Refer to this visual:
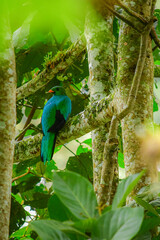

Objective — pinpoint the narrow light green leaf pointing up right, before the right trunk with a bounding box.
[112,170,145,209]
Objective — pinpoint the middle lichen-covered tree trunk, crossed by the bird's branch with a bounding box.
[85,9,114,202]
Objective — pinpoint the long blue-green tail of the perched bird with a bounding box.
[41,132,56,164]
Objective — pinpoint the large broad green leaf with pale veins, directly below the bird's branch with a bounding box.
[53,171,98,219]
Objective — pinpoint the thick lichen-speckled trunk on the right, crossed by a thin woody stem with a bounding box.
[117,0,156,199]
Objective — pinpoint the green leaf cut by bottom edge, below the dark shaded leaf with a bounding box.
[30,220,85,240]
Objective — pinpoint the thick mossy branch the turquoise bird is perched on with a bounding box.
[14,97,112,162]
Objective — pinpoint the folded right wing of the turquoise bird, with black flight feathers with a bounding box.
[48,96,71,132]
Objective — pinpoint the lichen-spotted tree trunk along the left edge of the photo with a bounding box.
[0,0,16,240]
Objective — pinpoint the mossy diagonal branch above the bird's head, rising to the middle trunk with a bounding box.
[16,35,85,100]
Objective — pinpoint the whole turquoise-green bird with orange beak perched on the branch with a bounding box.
[41,86,72,164]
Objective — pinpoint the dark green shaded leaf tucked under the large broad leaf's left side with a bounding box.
[48,194,75,222]
